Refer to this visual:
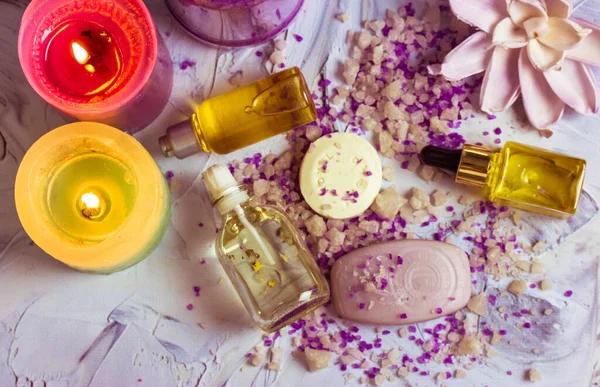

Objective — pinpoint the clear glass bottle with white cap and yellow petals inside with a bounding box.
[204,165,329,332]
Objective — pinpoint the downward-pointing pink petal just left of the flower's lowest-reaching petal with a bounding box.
[479,46,520,114]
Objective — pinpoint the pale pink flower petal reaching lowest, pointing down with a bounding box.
[519,48,565,129]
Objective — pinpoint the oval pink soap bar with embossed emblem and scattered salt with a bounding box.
[331,240,471,324]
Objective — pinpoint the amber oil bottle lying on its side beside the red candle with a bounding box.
[159,67,317,159]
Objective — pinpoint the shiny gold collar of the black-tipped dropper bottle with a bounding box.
[456,144,494,187]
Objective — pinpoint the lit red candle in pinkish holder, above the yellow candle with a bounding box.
[19,0,173,132]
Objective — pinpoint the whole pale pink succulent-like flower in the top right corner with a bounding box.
[429,0,600,129]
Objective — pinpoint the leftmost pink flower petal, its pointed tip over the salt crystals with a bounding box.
[429,31,492,80]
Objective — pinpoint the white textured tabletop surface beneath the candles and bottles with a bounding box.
[0,0,600,387]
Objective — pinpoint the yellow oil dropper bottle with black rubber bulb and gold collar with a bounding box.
[419,141,586,218]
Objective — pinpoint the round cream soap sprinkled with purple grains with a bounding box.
[300,133,381,219]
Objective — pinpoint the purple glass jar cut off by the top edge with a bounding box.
[165,0,304,47]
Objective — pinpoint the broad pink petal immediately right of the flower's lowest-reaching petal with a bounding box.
[544,59,598,115]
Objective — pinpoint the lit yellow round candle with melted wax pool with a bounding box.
[15,122,170,273]
